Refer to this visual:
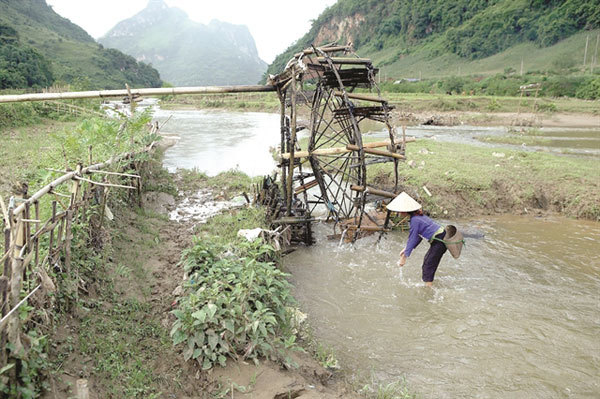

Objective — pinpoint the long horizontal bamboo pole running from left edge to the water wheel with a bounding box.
[0,85,277,103]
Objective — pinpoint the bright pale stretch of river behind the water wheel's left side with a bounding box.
[154,109,280,176]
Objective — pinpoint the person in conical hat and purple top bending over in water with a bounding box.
[387,192,447,287]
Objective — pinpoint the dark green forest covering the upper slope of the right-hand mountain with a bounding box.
[268,0,600,80]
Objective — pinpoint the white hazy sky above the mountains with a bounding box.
[46,0,336,63]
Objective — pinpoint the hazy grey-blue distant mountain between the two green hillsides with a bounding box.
[99,0,267,86]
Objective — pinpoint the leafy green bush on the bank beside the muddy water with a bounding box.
[171,237,295,370]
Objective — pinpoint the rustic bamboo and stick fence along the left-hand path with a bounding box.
[0,133,158,381]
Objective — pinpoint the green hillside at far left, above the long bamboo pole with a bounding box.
[0,0,162,90]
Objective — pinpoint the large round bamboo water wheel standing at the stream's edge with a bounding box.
[270,44,405,244]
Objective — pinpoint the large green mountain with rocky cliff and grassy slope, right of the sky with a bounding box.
[268,0,600,77]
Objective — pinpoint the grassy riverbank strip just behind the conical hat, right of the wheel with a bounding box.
[368,139,600,220]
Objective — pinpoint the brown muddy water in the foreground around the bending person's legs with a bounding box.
[285,217,600,398]
